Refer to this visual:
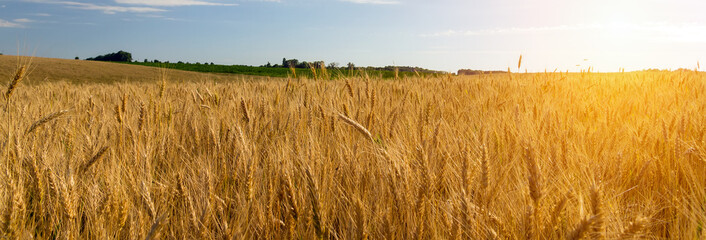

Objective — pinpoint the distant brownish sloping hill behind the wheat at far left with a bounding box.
[0,55,267,84]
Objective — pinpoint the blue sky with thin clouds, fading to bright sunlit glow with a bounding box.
[0,0,706,72]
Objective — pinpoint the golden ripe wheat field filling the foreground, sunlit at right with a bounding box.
[0,57,706,239]
